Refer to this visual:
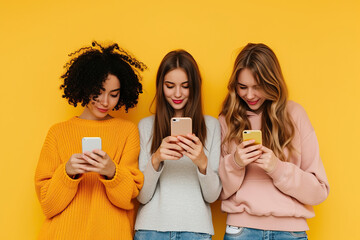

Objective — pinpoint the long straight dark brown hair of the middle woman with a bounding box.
[151,49,206,153]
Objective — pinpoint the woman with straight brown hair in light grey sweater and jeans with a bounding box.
[135,50,221,240]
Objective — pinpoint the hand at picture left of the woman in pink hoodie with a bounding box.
[234,140,262,167]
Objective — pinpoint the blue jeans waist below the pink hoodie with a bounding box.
[224,227,307,240]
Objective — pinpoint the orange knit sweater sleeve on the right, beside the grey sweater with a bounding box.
[100,126,144,210]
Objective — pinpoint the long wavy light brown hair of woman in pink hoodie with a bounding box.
[221,43,295,161]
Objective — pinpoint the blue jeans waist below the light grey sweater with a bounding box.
[134,230,211,240]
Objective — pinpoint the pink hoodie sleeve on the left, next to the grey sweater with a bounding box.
[219,115,245,200]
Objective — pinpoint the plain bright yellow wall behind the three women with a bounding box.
[0,0,360,240]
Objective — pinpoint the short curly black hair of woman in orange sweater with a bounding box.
[60,41,147,112]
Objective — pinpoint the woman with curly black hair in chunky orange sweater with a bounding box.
[35,42,146,240]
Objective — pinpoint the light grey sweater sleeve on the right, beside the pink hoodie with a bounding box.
[197,118,221,203]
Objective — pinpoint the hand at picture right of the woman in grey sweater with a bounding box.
[177,134,208,174]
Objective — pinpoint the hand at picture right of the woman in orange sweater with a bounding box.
[84,149,116,179]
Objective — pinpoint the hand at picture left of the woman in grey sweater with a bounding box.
[151,136,184,171]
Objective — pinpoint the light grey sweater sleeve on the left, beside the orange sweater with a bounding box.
[137,118,163,204]
